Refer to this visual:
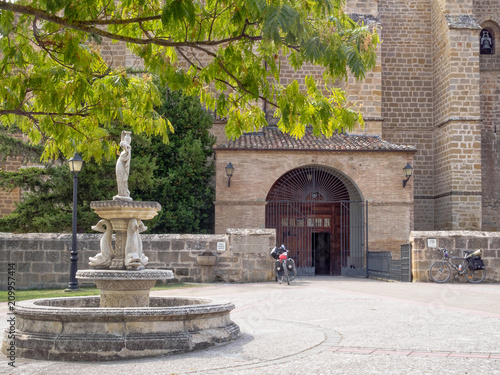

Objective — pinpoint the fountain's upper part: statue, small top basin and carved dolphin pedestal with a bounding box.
[89,131,161,271]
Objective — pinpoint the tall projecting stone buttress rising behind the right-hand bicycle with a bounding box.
[432,1,482,230]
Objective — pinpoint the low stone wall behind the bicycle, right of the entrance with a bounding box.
[410,231,500,282]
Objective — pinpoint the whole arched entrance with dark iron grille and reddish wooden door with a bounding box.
[266,166,366,276]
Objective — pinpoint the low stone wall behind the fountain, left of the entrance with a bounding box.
[0,229,276,290]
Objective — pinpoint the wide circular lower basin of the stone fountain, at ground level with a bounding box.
[3,297,240,361]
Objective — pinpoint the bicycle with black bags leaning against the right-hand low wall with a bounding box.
[429,249,486,284]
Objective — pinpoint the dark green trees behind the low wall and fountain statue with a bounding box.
[0,90,215,233]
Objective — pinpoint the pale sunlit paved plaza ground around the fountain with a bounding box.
[0,277,500,375]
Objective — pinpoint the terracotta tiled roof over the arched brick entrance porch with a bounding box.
[215,127,416,151]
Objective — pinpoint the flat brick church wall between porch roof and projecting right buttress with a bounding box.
[378,0,434,229]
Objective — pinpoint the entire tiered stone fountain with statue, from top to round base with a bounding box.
[2,131,240,361]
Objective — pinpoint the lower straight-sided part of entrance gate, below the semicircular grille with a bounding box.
[266,201,367,277]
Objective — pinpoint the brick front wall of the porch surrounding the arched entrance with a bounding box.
[215,150,413,253]
